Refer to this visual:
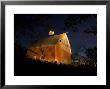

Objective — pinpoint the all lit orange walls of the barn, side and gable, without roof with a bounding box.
[26,33,72,64]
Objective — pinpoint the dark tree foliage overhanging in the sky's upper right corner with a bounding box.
[64,14,97,35]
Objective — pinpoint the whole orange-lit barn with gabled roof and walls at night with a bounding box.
[26,33,72,64]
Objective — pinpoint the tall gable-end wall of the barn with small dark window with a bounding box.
[55,33,71,64]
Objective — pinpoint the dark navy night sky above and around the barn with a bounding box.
[14,14,97,55]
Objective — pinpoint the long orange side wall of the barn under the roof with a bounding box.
[26,45,55,62]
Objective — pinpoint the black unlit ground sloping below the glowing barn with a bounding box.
[14,50,97,76]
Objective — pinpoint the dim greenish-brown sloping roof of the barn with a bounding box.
[32,35,59,47]
